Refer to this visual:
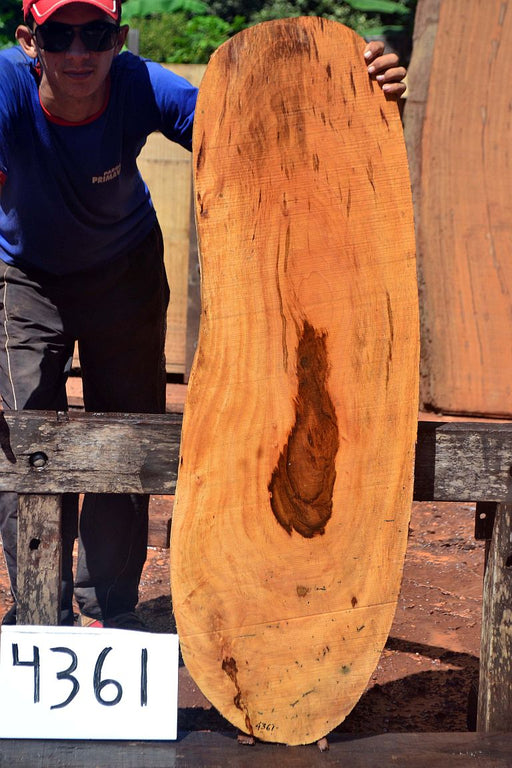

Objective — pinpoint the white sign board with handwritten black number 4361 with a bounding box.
[0,626,178,740]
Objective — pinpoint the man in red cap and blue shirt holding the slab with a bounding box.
[0,0,405,629]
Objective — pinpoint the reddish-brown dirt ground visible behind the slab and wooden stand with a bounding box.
[0,378,484,734]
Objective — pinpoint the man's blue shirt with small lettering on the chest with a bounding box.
[0,47,197,274]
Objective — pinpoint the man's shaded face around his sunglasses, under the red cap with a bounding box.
[33,3,126,111]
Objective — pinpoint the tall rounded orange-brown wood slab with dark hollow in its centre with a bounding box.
[171,18,418,744]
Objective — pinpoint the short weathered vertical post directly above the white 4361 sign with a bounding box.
[16,494,62,626]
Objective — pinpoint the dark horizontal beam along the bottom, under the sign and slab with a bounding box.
[0,731,512,768]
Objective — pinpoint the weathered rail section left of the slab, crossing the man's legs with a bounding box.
[0,411,182,494]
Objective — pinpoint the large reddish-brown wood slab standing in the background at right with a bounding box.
[405,0,512,416]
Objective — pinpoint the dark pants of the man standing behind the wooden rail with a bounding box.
[0,226,169,624]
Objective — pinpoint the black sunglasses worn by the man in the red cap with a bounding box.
[33,21,120,53]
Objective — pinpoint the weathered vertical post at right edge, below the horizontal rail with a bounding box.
[477,504,512,732]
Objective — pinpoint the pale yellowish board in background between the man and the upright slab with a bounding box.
[137,64,205,374]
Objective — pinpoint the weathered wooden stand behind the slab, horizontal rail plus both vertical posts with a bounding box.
[0,411,512,732]
